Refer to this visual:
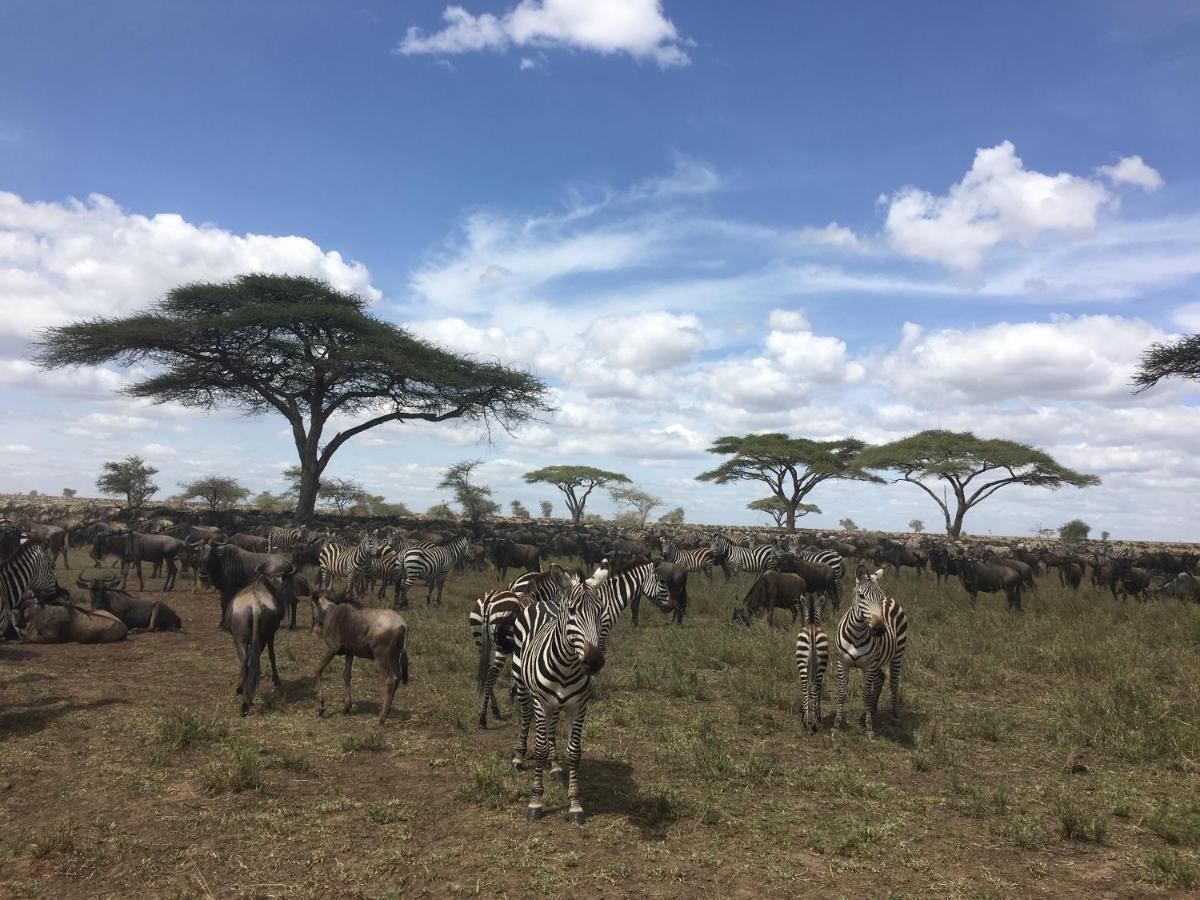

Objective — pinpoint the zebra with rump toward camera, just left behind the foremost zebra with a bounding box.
[467,565,580,728]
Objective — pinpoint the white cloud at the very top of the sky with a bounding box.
[396,0,691,68]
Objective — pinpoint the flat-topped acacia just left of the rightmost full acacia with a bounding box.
[696,432,880,532]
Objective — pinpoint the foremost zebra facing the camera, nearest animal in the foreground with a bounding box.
[521,586,606,824]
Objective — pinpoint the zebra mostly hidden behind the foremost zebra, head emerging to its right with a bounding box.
[511,563,673,775]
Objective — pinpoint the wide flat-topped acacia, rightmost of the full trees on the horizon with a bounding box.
[859,430,1100,538]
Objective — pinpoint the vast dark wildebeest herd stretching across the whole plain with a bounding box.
[0,498,1200,720]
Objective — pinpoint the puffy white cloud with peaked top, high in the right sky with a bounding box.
[886,140,1111,269]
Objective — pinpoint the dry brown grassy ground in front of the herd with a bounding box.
[0,561,1200,898]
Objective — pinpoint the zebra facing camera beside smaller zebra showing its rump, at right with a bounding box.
[833,566,908,739]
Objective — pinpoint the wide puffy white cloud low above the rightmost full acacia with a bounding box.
[876,316,1169,404]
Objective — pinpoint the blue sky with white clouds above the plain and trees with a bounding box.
[0,0,1200,539]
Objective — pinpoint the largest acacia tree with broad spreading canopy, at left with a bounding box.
[37,274,550,520]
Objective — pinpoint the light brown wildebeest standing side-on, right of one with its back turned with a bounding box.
[311,589,408,725]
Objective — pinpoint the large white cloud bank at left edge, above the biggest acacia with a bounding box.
[0,192,380,338]
